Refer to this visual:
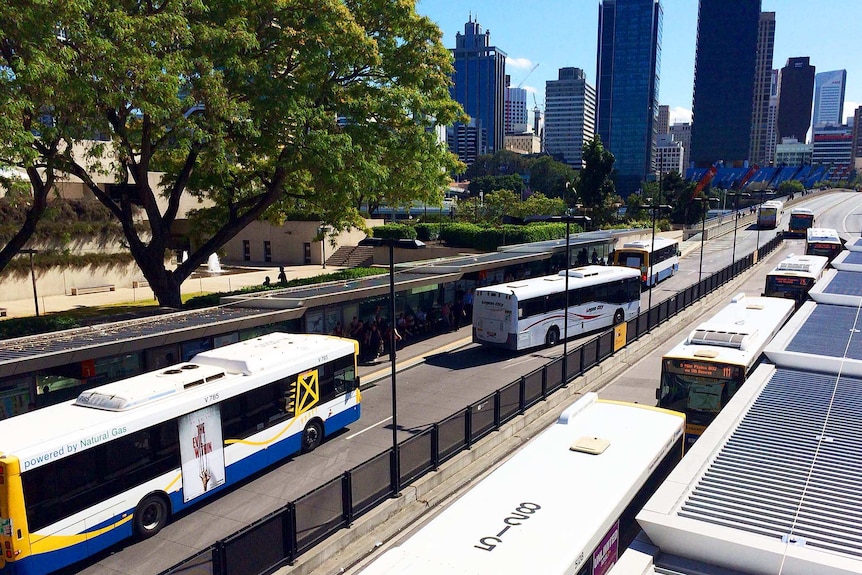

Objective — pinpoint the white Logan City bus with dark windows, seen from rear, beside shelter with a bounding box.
[473,265,641,350]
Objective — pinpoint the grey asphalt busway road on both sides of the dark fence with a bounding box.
[65,194,862,575]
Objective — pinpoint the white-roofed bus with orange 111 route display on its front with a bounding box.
[656,293,795,443]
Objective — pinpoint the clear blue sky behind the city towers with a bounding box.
[417,0,862,125]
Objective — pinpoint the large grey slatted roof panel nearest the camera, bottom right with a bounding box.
[677,369,862,559]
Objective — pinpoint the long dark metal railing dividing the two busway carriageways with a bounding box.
[160,236,783,575]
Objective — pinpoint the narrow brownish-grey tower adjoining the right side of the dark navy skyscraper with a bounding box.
[749,12,775,166]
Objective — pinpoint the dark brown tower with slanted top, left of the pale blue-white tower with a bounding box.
[778,56,814,142]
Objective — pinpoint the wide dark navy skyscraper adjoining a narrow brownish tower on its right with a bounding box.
[690,0,760,167]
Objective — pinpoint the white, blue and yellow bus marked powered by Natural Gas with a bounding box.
[0,333,360,575]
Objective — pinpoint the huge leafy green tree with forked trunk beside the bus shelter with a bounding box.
[0,0,463,307]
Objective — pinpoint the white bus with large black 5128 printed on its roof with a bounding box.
[360,393,685,575]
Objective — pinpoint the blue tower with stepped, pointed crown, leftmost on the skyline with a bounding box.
[449,17,506,162]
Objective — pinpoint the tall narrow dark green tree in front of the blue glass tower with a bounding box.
[576,134,617,226]
